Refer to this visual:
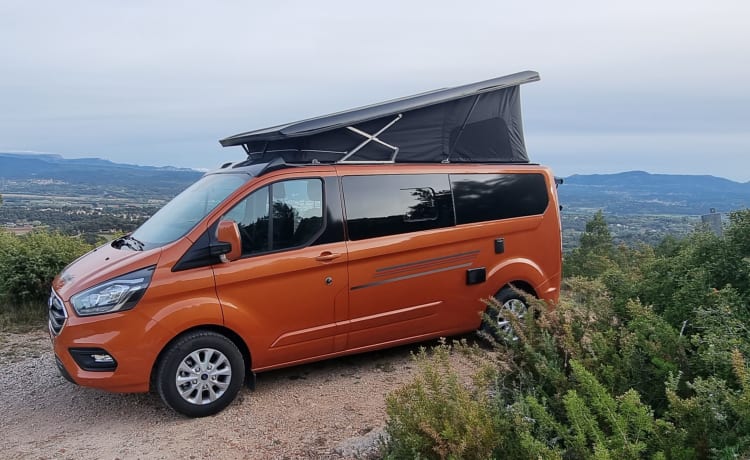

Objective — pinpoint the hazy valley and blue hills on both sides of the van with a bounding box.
[0,153,750,248]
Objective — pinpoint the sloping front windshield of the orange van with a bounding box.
[132,174,251,248]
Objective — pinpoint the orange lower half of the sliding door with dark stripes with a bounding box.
[349,230,478,348]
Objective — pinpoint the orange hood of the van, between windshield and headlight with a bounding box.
[52,243,162,302]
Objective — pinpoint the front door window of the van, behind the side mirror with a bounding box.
[223,179,323,255]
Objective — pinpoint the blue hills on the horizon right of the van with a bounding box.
[558,171,750,215]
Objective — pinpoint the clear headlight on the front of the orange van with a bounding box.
[70,267,155,316]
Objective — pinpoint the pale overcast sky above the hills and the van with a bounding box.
[0,0,750,182]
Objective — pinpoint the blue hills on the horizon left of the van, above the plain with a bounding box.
[0,152,203,198]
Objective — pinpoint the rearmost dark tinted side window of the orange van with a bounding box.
[450,174,549,224]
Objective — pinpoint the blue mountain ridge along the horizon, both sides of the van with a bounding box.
[0,152,750,215]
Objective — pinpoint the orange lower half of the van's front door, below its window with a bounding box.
[214,242,347,368]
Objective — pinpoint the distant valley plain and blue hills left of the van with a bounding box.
[0,153,203,243]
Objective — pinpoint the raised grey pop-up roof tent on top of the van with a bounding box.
[220,71,539,163]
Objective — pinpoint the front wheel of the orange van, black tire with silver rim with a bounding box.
[156,331,245,417]
